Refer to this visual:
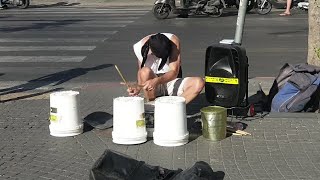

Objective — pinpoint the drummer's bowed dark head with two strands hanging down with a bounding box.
[141,33,172,70]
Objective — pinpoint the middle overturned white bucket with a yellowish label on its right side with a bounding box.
[112,97,147,144]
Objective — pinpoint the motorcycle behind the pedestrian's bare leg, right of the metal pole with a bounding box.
[256,0,309,15]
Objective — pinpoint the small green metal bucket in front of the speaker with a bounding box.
[200,106,227,141]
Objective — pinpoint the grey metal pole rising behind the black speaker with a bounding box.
[234,0,248,45]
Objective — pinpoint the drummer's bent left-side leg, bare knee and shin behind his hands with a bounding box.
[138,67,157,101]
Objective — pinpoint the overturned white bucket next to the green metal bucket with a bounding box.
[153,96,189,146]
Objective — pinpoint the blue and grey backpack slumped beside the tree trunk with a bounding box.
[269,64,320,112]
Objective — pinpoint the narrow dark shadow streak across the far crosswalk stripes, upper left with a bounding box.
[0,19,84,32]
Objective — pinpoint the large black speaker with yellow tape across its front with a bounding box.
[205,44,248,108]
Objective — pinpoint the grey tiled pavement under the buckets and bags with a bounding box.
[0,80,320,180]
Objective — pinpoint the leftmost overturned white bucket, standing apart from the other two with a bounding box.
[49,91,83,137]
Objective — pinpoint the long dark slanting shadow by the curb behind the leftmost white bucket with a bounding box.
[0,64,113,95]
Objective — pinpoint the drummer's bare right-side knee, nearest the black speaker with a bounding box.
[180,77,204,103]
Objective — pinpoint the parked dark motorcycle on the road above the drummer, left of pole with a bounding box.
[152,0,226,19]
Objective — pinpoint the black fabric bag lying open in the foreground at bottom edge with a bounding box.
[89,150,215,180]
